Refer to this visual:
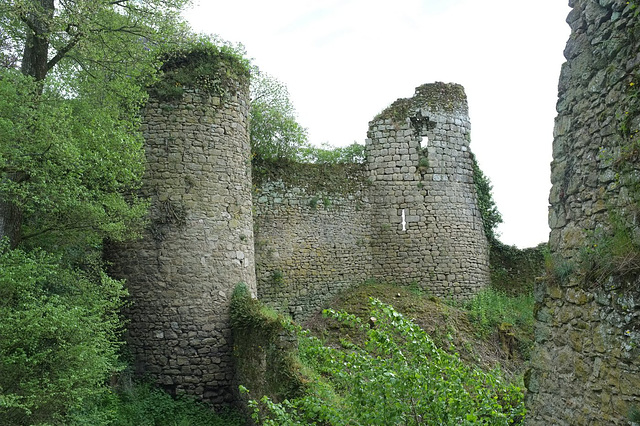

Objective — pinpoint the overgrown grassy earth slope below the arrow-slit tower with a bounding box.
[303,283,533,379]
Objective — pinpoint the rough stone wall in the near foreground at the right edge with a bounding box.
[526,0,640,425]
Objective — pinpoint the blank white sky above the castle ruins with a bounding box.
[185,0,570,247]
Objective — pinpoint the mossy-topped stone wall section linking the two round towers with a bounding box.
[254,164,371,320]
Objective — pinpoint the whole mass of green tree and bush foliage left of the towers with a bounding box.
[0,0,205,425]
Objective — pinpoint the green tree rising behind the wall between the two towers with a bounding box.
[249,71,308,160]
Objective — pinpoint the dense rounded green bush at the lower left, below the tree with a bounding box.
[0,243,124,425]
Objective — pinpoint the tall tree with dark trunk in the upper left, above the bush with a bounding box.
[0,0,188,247]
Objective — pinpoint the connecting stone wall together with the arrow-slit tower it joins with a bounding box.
[254,83,489,319]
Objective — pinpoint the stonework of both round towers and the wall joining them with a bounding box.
[108,83,489,405]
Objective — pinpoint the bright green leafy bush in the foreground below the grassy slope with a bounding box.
[253,299,524,425]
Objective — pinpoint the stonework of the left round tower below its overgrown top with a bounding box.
[109,85,255,405]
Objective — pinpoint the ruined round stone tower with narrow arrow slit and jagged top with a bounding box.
[366,83,489,299]
